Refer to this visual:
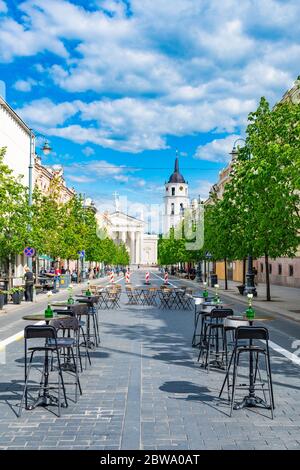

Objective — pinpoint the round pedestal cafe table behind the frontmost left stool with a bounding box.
[22,313,70,410]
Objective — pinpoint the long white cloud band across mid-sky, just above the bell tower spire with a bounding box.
[18,98,255,153]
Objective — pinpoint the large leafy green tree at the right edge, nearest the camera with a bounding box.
[218,98,300,300]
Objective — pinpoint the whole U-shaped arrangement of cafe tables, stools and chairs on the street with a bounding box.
[19,284,274,418]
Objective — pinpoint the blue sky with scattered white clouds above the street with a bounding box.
[0,0,300,221]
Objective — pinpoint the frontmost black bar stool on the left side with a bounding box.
[18,325,68,417]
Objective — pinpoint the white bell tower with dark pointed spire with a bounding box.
[163,156,190,234]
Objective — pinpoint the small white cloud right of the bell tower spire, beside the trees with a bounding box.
[194,134,240,163]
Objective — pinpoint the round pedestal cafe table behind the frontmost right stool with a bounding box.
[222,316,267,410]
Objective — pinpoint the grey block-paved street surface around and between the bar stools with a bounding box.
[0,273,300,450]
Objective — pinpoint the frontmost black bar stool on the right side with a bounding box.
[219,326,275,419]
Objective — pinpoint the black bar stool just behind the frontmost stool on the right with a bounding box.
[198,308,233,372]
